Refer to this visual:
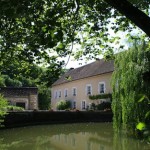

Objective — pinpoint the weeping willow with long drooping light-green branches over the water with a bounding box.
[112,43,150,131]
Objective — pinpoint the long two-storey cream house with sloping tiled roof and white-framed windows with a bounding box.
[51,59,114,110]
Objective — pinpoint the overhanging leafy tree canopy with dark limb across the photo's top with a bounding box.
[0,0,150,64]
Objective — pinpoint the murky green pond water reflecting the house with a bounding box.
[0,123,150,150]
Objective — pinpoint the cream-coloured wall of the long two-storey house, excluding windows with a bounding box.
[51,73,112,110]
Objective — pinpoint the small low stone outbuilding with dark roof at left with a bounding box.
[0,87,38,110]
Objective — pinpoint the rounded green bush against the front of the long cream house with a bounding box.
[57,100,71,110]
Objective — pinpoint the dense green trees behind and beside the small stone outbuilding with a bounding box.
[0,61,63,109]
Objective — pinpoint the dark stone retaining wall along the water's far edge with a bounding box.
[3,111,113,128]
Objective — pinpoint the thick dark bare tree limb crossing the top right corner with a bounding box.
[105,0,150,37]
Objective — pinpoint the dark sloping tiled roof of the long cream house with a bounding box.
[53,59,114,86]
